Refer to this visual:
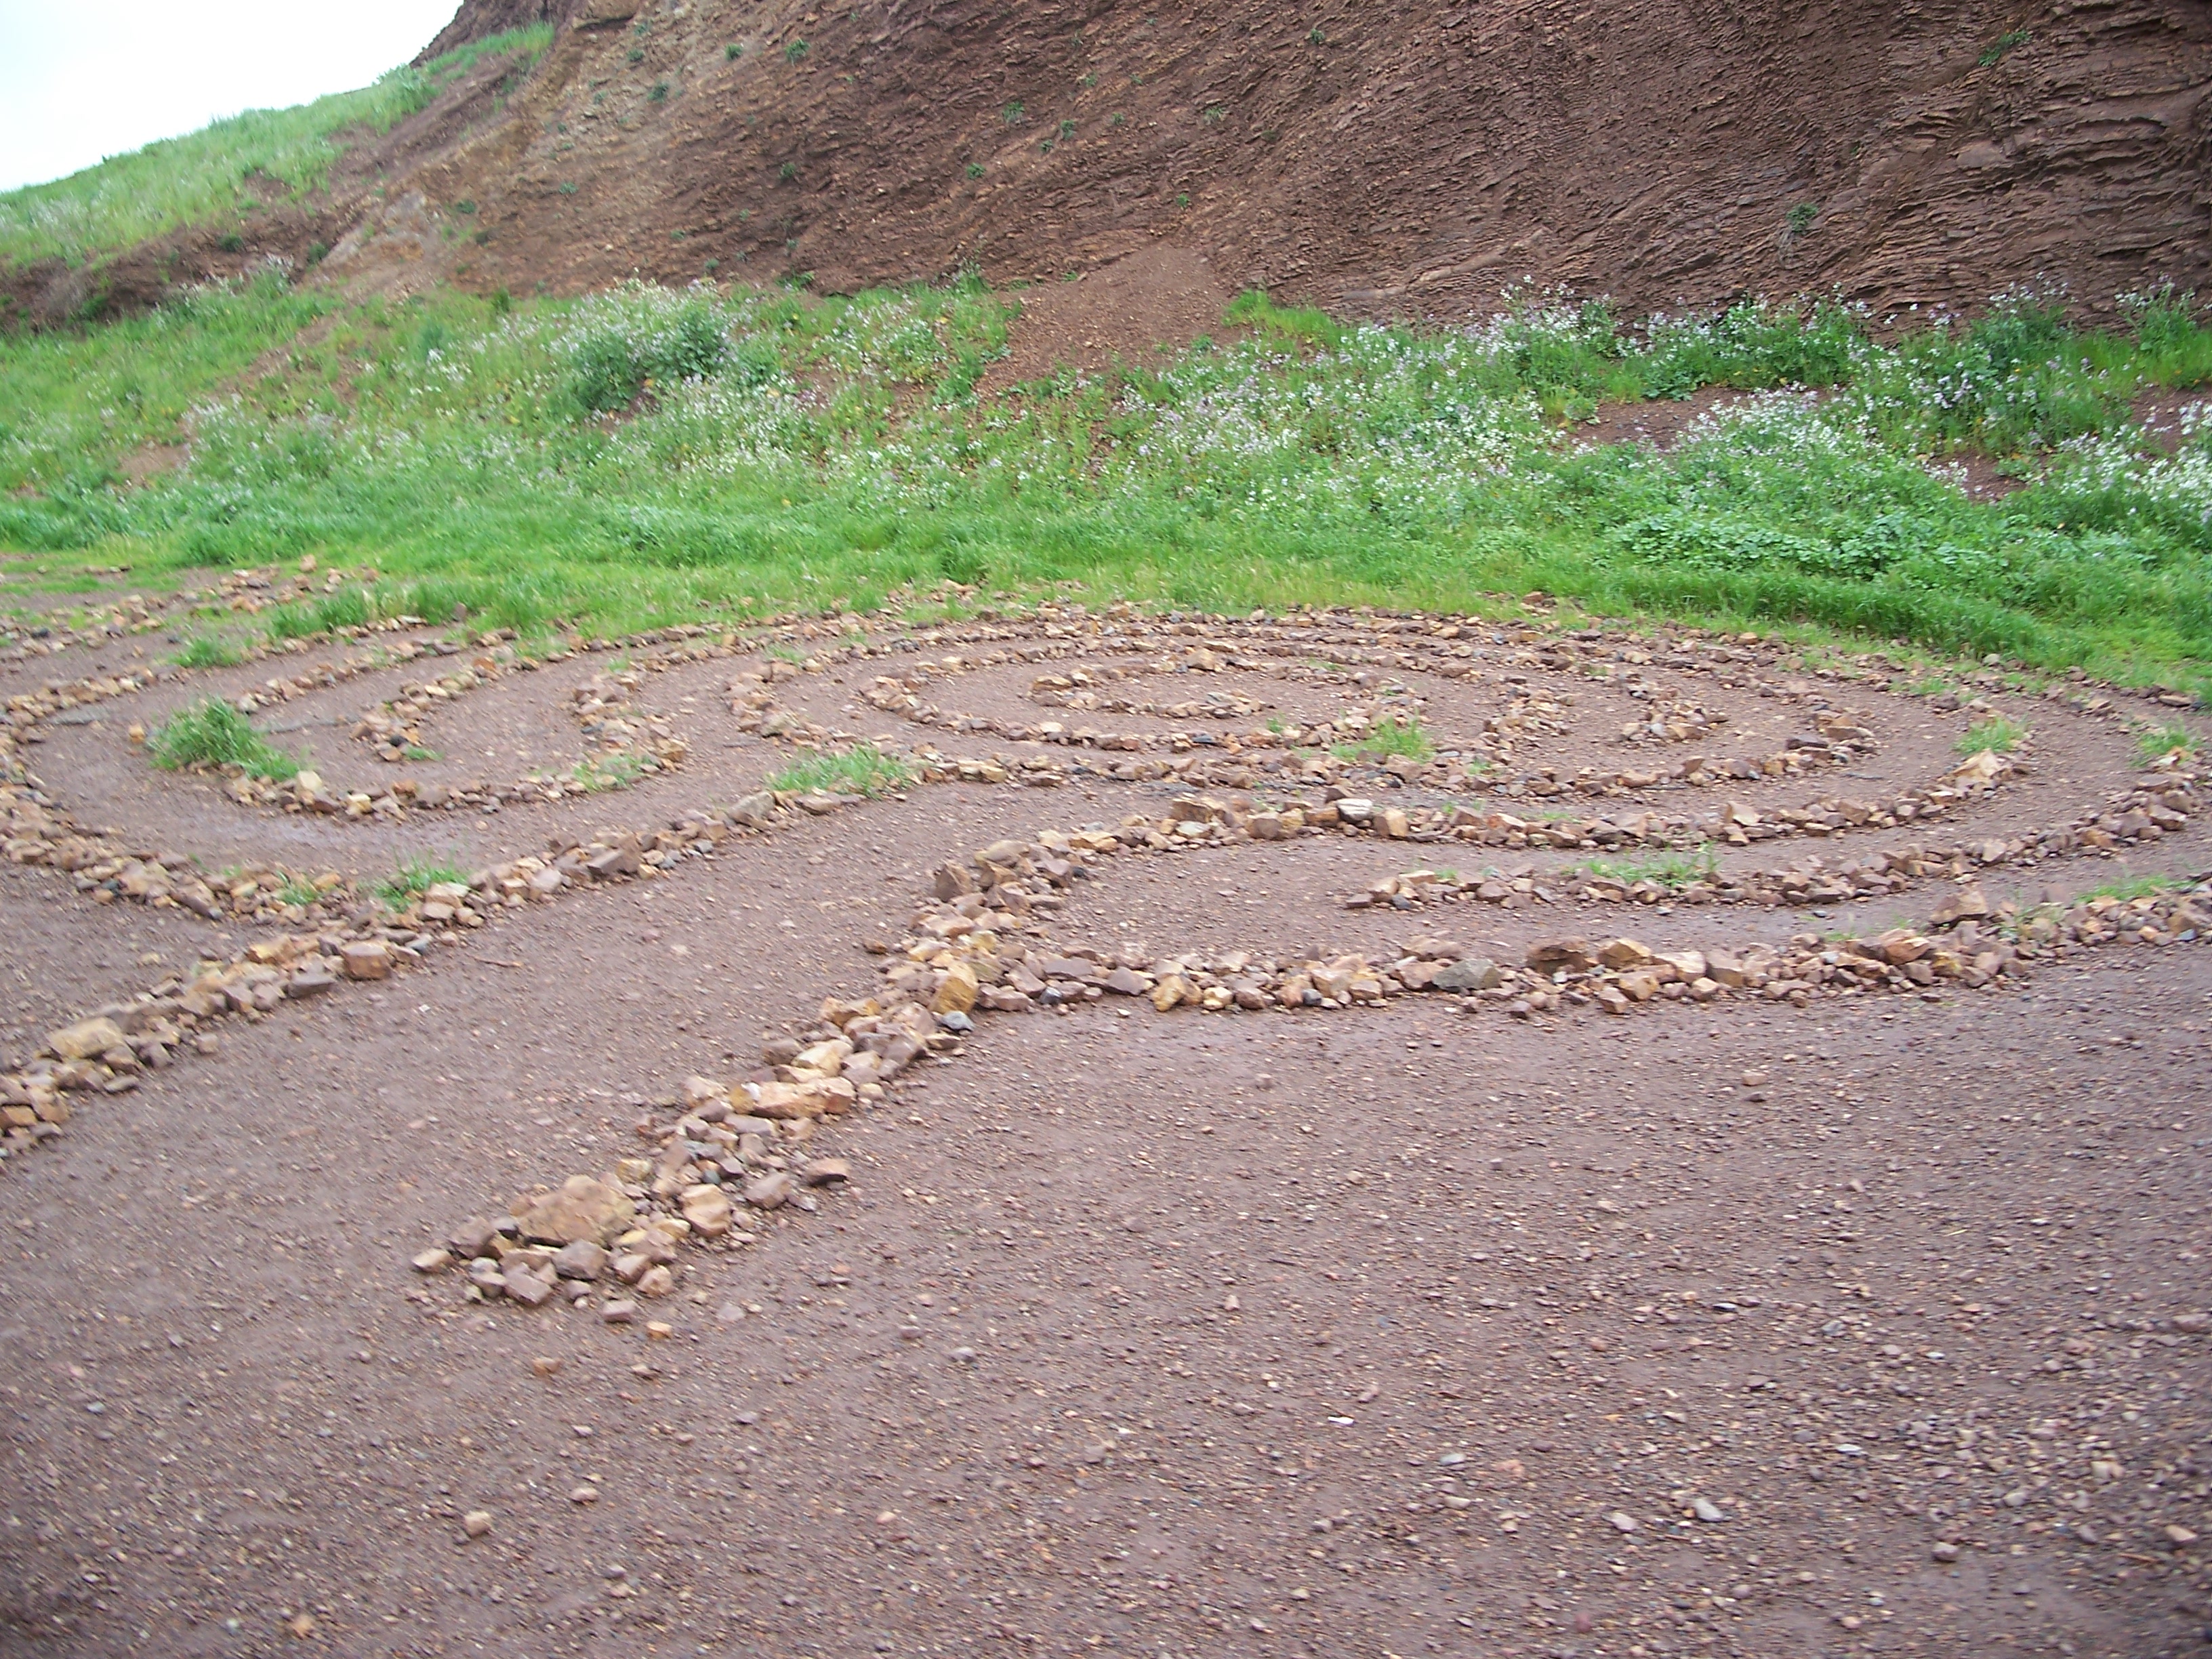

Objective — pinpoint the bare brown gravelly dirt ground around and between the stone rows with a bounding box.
[0,588,2212,1659]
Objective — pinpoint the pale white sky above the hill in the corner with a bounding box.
[0,0,460,190]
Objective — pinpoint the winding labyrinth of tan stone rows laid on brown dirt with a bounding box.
[0,571,2212,1652]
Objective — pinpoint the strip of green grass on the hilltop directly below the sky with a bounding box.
[0,24,553,268]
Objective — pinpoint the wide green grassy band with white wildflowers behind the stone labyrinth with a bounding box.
[0,267,2212,684]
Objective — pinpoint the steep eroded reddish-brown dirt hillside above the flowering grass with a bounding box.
[392,0,2212,314]
